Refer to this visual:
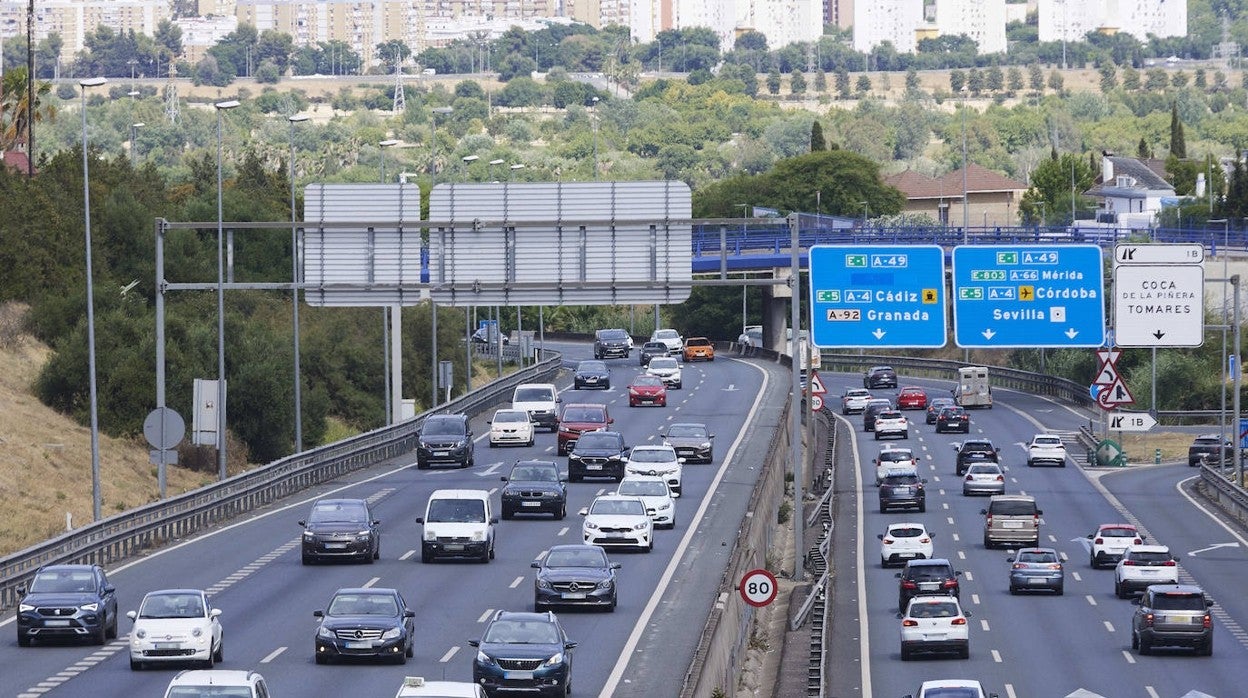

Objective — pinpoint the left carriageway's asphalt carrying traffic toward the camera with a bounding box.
[0,345,787,698]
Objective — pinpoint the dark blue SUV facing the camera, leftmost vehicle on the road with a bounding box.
[17,564,117,647]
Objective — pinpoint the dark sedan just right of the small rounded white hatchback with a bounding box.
[312,587,416,664]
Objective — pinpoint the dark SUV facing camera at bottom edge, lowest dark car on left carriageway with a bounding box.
[468,611,577,698]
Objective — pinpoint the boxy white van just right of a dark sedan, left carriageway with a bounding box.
[416,489,498,562]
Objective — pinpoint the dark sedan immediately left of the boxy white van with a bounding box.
[300,499,382,564]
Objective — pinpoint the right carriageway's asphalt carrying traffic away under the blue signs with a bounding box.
[824,375,1248,698]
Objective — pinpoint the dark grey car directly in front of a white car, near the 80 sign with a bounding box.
[532,546,620,612]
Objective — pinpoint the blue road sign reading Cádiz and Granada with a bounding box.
[810,245,948,348]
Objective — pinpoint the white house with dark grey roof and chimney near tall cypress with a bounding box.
[1083,154,1174,226]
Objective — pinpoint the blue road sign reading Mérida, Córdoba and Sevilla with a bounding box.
[952,245,1104,348]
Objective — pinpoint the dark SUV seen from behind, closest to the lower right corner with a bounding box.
[1131,584,1213,657]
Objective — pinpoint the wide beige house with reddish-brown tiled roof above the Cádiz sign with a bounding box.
[884,162,1027,227]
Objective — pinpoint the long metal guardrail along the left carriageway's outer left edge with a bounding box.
[0,351,562,611]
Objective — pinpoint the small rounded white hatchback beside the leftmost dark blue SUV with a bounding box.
[126,589,223,671]
